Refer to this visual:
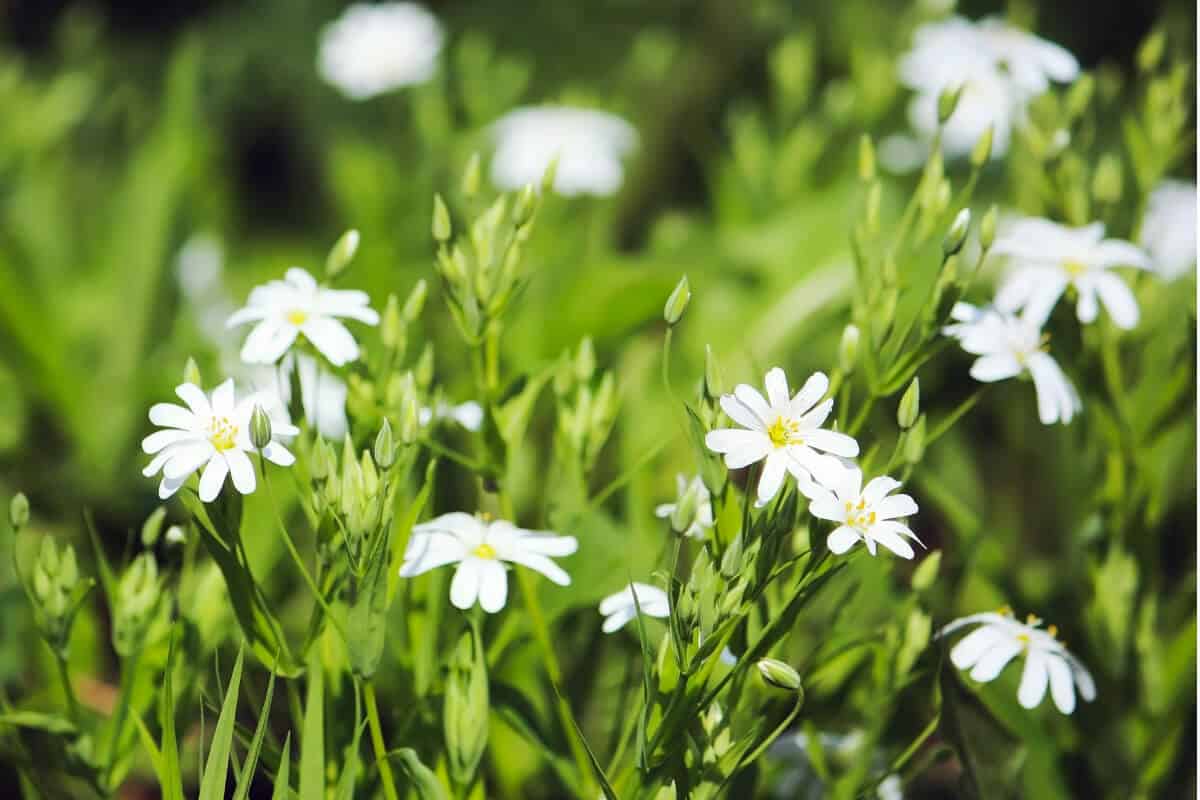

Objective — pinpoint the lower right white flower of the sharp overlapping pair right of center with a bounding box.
[809,468,920,559]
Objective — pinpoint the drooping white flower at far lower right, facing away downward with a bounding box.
[938,609,1096,714]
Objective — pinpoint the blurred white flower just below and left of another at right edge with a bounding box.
[942,302,1082,425]
